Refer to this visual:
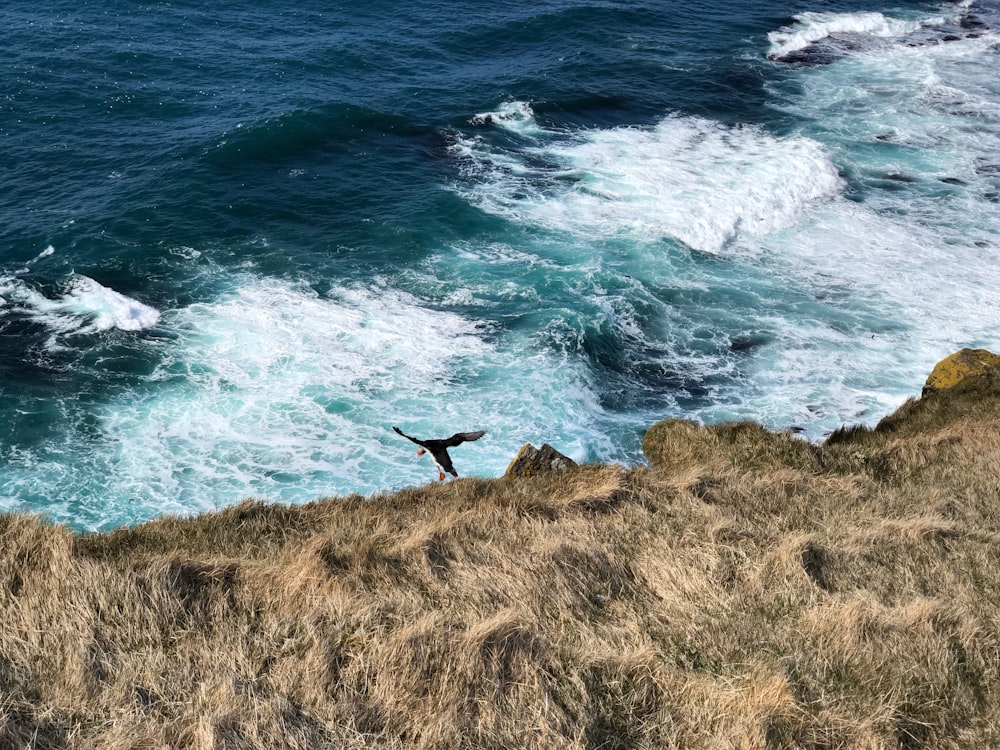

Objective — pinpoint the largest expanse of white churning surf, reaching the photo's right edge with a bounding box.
[444,4,1000,452]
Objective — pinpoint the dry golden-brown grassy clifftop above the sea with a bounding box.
[0,354,1000,750]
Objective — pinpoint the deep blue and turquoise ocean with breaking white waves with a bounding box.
[0,0,1000,531]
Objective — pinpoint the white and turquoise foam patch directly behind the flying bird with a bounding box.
[9,276,610,528]
